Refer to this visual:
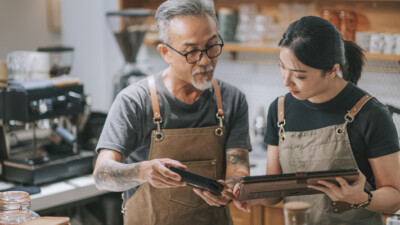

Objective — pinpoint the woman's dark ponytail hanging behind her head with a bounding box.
[342,41,365,84]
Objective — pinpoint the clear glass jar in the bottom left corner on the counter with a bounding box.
[0,191,40,224]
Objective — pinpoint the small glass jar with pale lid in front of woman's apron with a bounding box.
[283,201,310,225]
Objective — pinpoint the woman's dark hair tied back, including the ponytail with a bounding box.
[279,16,365,84]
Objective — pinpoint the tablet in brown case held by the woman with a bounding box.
[238,169,358,200]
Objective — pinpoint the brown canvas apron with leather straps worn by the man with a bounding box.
[123,76,232,225]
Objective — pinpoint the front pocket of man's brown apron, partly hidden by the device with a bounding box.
[168,160,217,208]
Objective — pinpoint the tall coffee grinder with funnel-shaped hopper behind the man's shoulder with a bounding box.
[106,9,153,98]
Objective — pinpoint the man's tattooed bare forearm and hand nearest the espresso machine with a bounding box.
[93,149,186,192]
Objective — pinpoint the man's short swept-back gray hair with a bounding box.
[156,0,218,43]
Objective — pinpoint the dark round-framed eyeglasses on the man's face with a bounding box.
[164,34,224,64]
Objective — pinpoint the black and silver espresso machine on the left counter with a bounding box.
[0,78,94,185]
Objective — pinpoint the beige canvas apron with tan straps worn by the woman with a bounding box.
[278,95,383,225]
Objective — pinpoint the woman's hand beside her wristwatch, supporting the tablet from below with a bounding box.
[307,171,368,204]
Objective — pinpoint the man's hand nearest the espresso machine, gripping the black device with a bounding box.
[140,158,186,188]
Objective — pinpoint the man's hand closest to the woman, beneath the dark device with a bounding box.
[193,180,233,207]
